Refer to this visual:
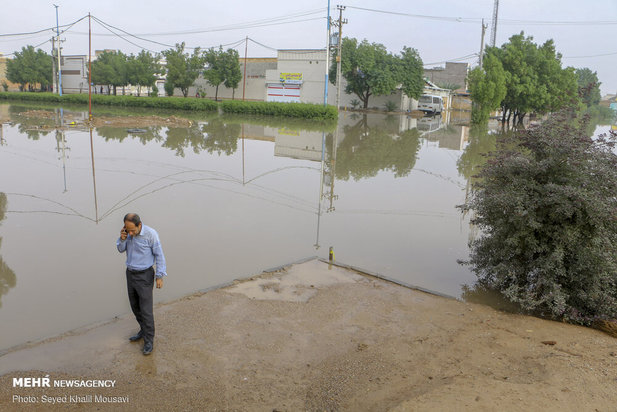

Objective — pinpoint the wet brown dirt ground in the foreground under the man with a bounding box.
[0,260,617,411]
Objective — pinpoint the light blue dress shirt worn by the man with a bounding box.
[116,223,167,278]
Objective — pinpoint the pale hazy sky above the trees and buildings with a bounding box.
[0,0,617,95]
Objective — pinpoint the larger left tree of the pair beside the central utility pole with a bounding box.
[329,37,402,109]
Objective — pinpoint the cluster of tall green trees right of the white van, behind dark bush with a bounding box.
[469,32,600,123]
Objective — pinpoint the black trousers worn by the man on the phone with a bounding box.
[126,268,154,342]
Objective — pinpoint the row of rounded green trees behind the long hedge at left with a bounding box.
[7,43,242,99]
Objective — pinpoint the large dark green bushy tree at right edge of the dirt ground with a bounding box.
[461,113,617,325]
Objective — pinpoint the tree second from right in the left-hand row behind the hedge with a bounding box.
[163,42,204,97]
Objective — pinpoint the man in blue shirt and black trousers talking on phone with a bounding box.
[116,213,167,355]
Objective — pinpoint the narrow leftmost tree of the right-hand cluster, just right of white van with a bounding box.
[469,54,506,124]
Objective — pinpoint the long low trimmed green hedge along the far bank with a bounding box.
[0,92,338,120]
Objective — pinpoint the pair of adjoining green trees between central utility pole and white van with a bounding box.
[329,37,424,109]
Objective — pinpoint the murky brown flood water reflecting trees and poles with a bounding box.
[0,105,600,350]
